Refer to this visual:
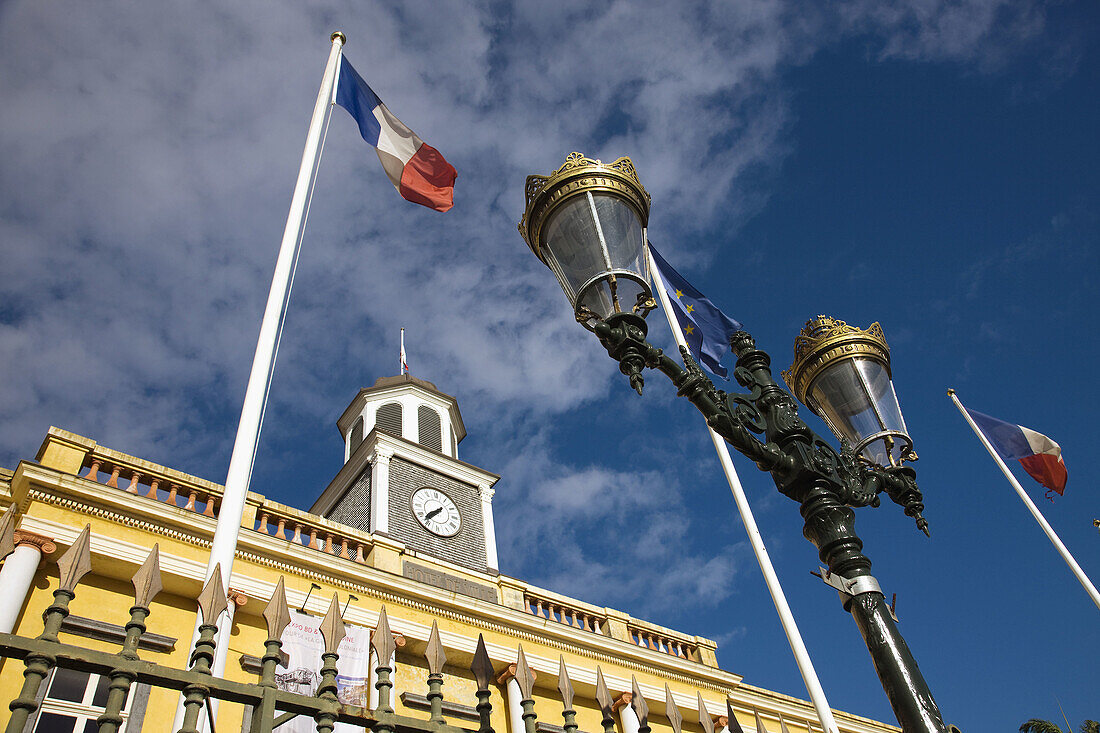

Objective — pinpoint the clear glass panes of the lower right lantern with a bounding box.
[806,357,912,466]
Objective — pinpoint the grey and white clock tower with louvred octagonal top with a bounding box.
[309,374,499,573]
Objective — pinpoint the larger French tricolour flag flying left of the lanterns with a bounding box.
[337,56,458,211]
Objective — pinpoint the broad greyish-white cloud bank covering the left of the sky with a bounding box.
[0,0,1069,611]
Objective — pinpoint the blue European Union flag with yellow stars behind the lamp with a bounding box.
[649,244,741,379]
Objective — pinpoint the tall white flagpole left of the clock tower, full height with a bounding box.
[172,32,345,730]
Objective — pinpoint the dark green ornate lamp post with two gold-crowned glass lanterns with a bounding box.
[519,153,947,733]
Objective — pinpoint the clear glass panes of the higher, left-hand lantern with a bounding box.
[541,190,650,321]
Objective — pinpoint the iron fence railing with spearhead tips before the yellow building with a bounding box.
[0,507,739,733]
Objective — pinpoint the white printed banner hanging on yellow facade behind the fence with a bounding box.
[275,611,371,733]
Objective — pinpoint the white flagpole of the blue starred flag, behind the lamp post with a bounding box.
[646,244,840,733]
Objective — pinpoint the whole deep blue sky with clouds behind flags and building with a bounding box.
[0,0,1100,731]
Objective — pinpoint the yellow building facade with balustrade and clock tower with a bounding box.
[0,376,899,733]
